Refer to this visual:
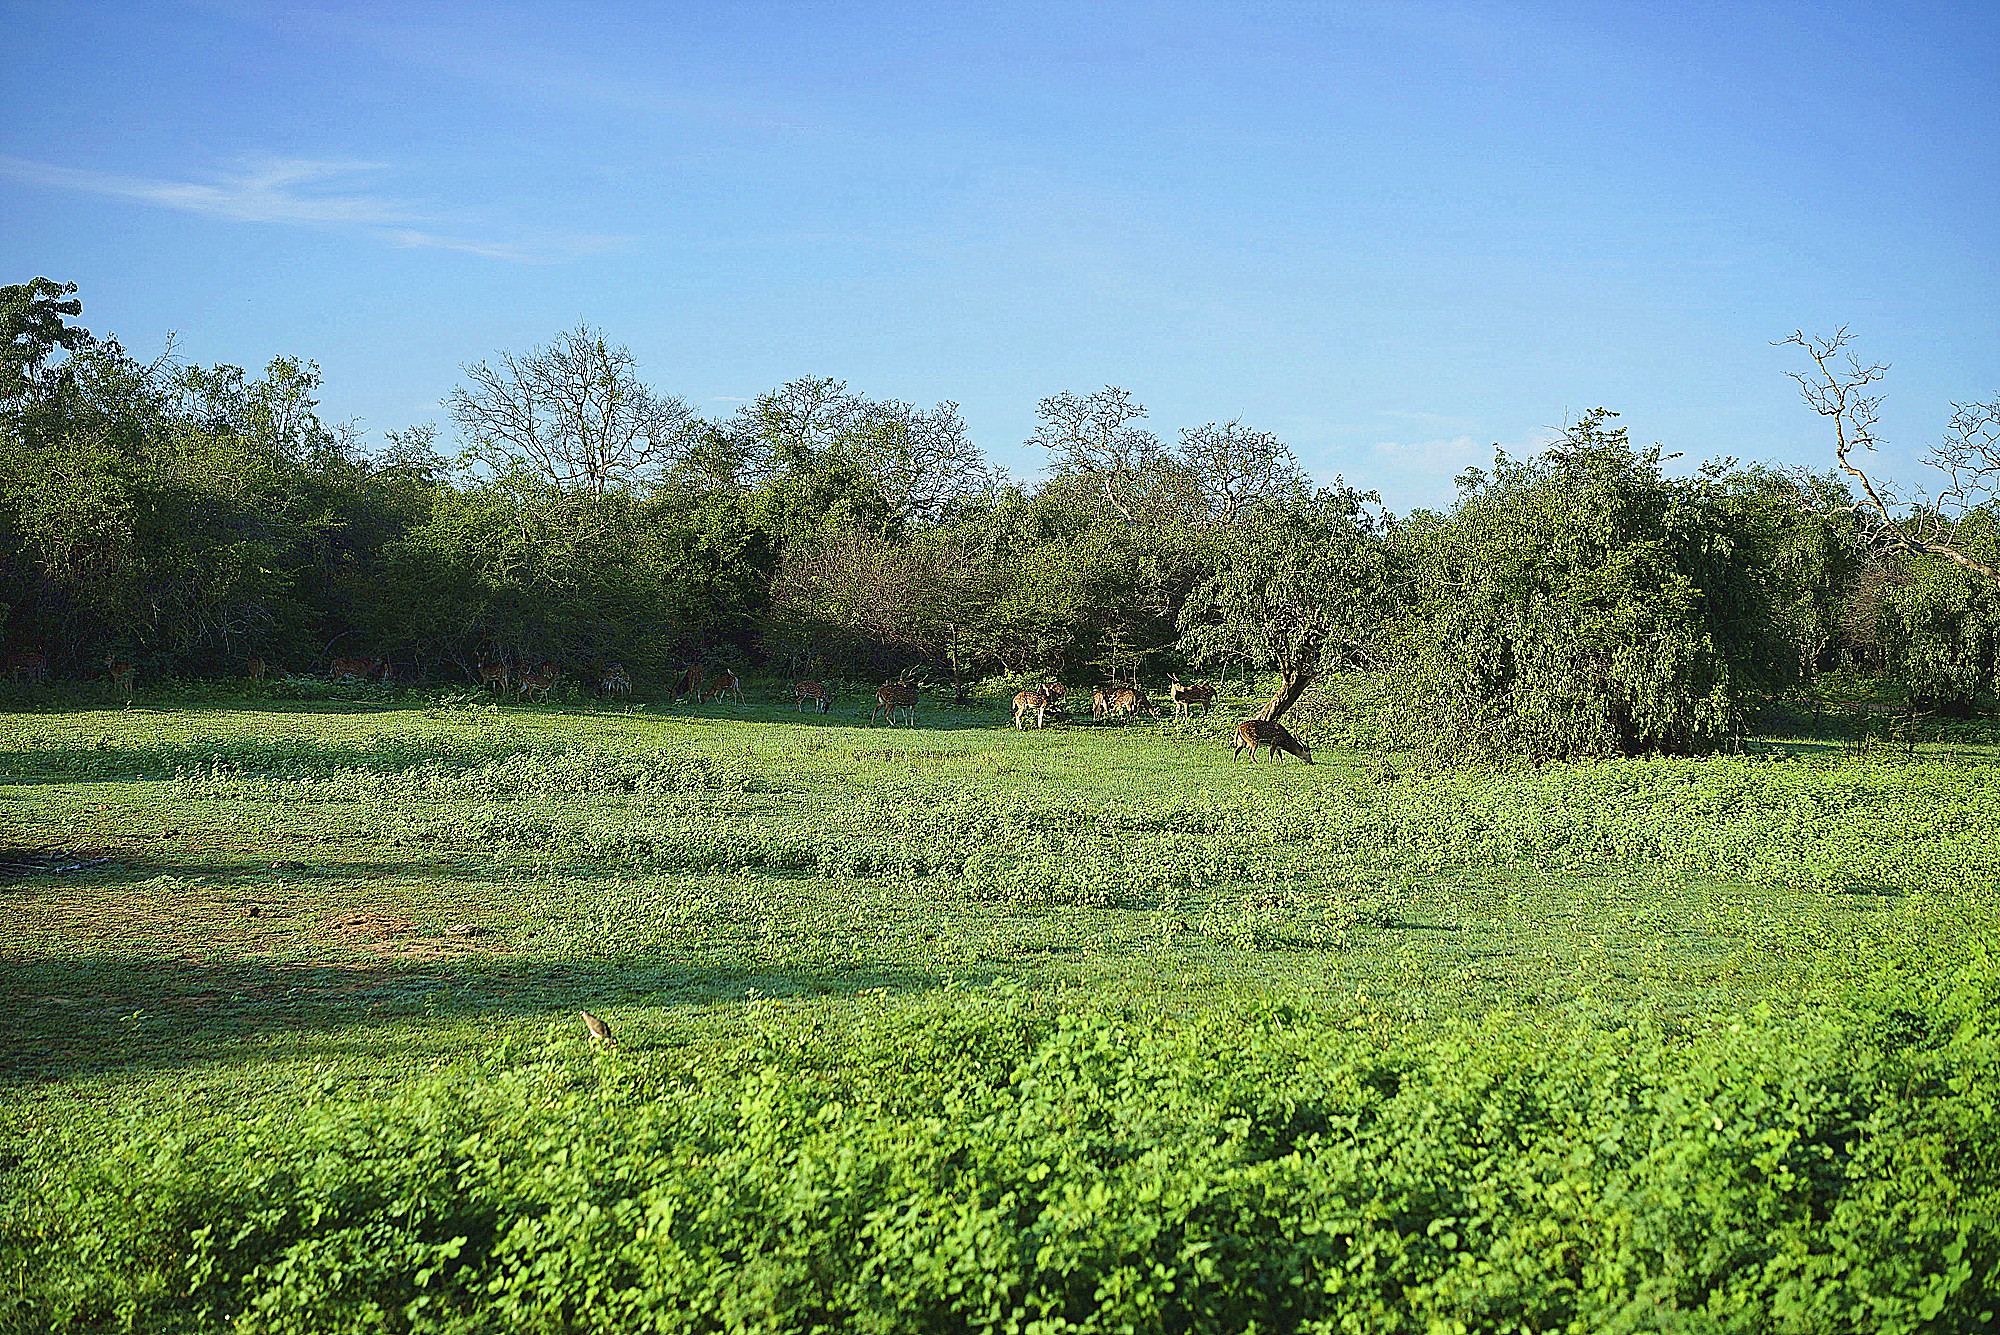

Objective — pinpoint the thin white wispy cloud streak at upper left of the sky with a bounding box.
[0,156,620,264]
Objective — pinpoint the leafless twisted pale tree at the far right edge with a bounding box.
[1778,326,2000,584]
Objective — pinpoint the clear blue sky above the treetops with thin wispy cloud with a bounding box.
[0,0,2000,510]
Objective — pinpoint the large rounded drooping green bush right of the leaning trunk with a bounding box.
[1386,410,1790,759]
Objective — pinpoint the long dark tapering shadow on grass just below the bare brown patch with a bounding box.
[0,951,968,1085]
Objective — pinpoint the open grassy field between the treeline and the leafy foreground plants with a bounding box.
[0,689,2000,1329]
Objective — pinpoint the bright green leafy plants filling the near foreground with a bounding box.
[0,959,2000,1335]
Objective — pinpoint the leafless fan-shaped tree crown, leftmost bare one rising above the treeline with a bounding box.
[446,324,698,494]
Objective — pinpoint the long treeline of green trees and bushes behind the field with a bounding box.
[0,280,2000,757]
